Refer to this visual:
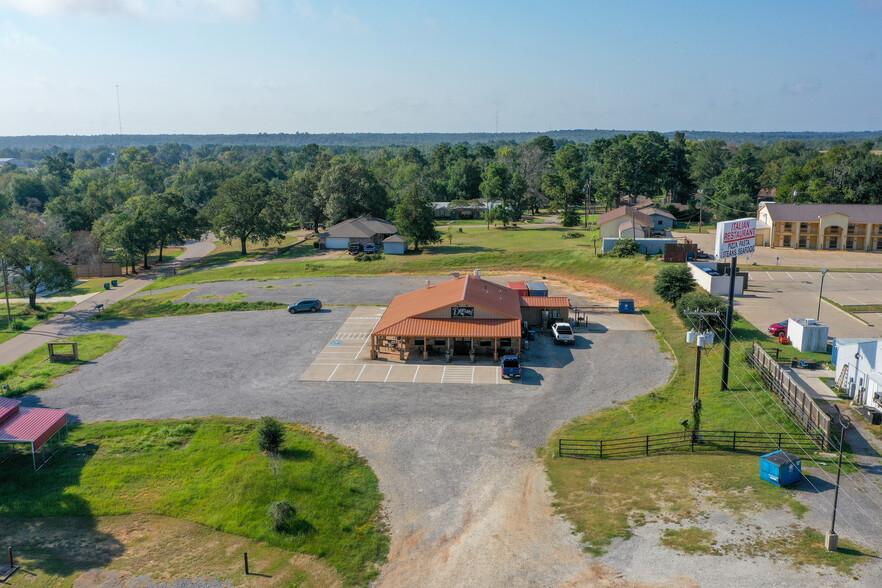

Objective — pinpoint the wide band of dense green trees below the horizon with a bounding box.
[0,132,882,308]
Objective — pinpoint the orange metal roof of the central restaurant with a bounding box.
[373,275,521,337]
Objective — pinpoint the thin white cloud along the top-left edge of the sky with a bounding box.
[0,0,261,20]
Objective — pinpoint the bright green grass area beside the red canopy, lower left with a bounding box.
[0,417,389,584]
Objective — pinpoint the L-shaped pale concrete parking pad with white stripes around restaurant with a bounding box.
[300,306,511,384]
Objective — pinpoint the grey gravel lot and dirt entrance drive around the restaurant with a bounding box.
[25,296,672,586]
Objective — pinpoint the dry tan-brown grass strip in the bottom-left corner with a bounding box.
[0,514,342,588]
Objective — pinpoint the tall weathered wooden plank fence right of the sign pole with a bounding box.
[748,343,831,449]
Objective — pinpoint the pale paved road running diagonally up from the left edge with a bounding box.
[0,239,214,365]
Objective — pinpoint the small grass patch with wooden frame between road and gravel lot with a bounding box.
[0,333,125,398]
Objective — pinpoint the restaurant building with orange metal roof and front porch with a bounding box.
[370,270,570,361]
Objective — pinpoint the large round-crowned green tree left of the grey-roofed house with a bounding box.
[203,172,287,255]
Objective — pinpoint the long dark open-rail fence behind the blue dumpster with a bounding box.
[557,431,824,459]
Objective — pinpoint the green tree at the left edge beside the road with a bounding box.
[0,235,76,309]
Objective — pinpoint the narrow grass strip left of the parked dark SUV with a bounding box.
[90,288,287,321]
